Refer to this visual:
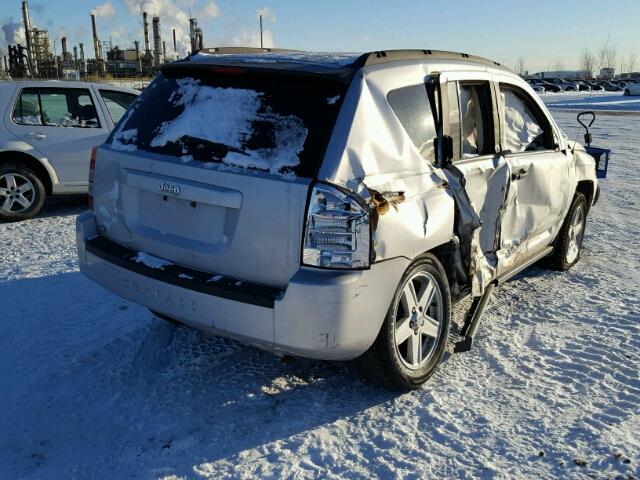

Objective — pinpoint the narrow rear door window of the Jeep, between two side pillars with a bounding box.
[459,83,494,158]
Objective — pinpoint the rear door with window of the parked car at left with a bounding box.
[6,87,108,186]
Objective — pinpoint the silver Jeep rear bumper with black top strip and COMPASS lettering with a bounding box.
[76,212,409,360]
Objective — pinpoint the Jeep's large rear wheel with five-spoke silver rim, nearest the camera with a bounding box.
[358,254,451,390]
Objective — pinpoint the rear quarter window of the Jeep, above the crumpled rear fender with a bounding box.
[387,84,437,162]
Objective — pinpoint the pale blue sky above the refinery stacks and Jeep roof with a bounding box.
[0,0,640,72]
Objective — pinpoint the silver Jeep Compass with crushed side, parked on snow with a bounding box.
[77,49,599,389]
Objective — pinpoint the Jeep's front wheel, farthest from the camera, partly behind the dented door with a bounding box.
[548,192,588,271]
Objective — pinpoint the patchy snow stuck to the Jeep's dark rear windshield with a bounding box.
[151,78,308,173]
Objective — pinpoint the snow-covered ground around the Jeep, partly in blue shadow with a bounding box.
[0,112,640,479]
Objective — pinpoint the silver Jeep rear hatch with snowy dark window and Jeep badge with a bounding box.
[93,64,347,287]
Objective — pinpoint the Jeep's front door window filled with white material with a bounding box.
[500,85,550,152]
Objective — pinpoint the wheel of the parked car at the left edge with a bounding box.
[0,164,47,222]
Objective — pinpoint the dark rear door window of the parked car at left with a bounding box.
[13,88,100,128]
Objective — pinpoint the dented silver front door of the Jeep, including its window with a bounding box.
[496,77,571,271]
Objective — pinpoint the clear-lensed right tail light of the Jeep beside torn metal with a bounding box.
[302,183,371,269]
